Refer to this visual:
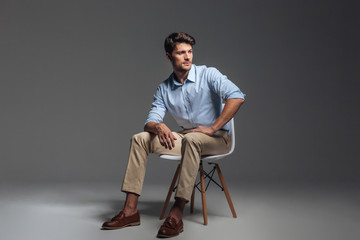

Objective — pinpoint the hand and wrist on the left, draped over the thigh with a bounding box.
[144,122,176,150]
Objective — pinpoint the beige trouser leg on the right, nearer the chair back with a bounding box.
[175,130,231,201]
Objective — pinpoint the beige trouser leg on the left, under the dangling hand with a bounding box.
[121,132,183,195]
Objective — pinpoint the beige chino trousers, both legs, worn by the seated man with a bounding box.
[121,130,231,201]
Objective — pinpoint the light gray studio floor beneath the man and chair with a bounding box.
[0,183,360,240]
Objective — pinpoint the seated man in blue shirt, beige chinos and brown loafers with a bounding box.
[103,32,245,237]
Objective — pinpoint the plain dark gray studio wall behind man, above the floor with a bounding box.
[0,0,360,184]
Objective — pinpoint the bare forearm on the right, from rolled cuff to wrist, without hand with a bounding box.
[211,98,244,131]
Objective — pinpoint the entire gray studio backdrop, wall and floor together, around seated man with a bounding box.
[0,0,360,240]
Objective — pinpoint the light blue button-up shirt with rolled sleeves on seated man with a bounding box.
[145,64,245,130]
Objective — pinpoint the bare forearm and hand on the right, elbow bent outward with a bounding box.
[193,98,244,136]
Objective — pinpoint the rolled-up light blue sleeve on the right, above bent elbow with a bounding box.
[209,68,246,101]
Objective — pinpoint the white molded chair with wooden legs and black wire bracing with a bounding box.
[160,119,236,225]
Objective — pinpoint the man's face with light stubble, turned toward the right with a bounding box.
[166,43,193,72]
